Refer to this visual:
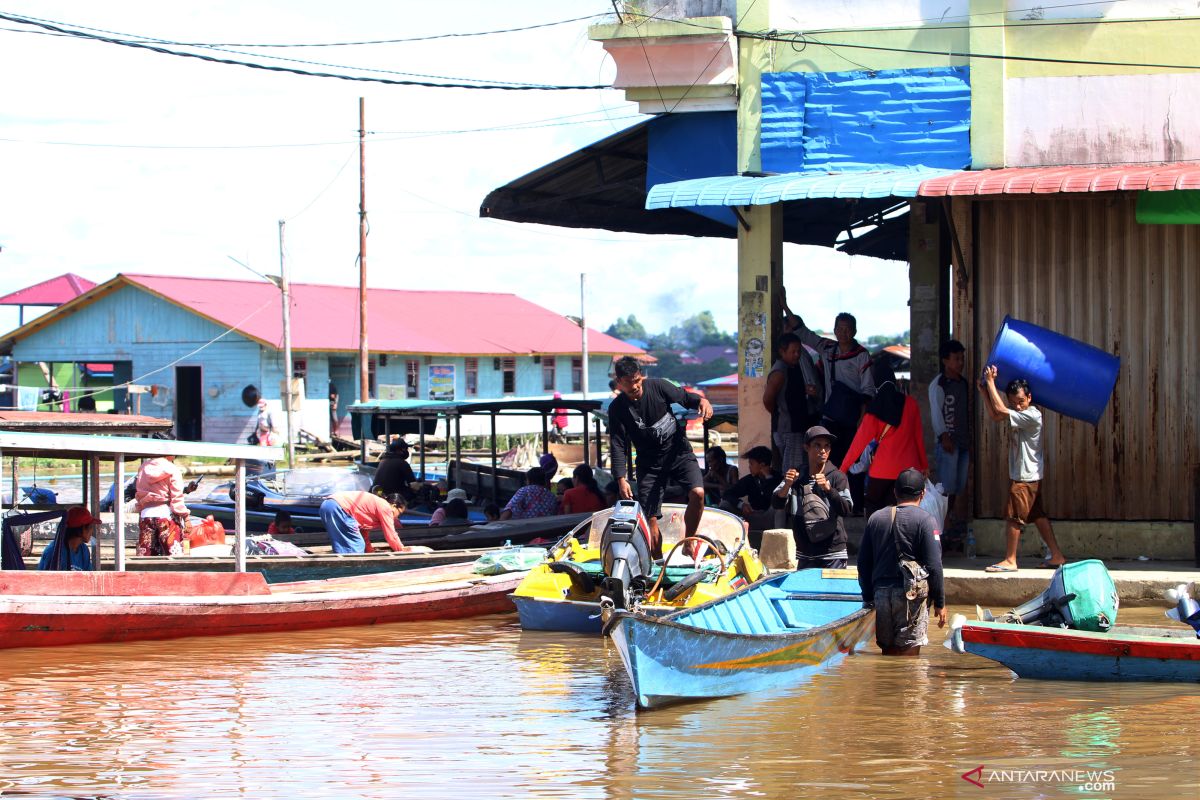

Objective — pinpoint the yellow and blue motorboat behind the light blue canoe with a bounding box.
[512,504,763,633]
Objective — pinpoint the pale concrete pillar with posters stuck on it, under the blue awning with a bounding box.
[737,204,784,475]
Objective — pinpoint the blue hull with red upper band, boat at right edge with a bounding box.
[950,621,1200,684]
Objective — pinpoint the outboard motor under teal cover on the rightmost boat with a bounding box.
[1001,559,1120,632]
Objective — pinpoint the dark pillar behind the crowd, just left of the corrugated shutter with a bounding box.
[908,200,946,465]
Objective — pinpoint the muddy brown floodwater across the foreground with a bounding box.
[0,609,1200,800]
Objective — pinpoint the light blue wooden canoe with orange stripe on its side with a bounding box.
[605,570,875,709]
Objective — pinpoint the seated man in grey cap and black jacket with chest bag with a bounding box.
[772,425,854,570]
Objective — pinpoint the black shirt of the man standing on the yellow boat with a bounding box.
[608,378,700,479]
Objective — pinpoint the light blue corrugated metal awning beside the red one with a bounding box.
[646,167,960,210]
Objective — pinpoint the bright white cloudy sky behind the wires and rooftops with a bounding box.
[0,0,908,335]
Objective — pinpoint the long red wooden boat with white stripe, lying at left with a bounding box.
[0,564,526,648]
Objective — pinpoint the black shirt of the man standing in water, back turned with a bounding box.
[858,504,946,608]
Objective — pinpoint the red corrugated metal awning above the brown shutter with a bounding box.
[918,164,1200,197]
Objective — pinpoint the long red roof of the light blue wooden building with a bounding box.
[26,275,642,355]
